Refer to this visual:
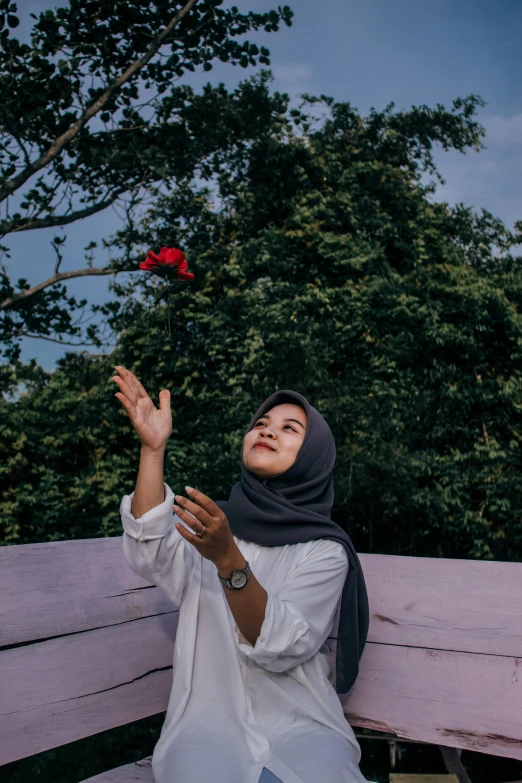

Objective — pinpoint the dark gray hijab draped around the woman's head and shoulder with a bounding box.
[217,389,370,694]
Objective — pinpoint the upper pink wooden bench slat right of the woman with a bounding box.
[359,555,522,657]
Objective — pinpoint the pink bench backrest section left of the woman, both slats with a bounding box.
[0,536,178,764]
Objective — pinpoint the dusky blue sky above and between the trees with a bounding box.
[2,0,522,370]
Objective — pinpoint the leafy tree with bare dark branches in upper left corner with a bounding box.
[0,0,292,359]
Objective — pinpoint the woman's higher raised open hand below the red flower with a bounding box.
[112,364,172,451]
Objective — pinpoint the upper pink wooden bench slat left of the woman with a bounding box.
[0,536,173,647]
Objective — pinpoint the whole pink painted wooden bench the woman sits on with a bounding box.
[0,537,522,783]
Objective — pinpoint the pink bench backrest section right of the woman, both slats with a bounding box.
[343,555,522,759]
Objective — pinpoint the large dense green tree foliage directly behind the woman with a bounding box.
[0,75,522,560]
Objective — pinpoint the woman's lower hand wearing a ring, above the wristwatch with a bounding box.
[174,487,238,568]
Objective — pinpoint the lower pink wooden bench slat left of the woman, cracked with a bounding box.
[0,616,179,764]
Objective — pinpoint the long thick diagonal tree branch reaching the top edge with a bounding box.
[0,0,197,203]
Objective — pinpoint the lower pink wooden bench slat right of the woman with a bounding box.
[342,643,522,759]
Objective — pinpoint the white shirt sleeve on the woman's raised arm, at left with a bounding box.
[120,484,193,607]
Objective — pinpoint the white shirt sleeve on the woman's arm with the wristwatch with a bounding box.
[235,539,348,672]
